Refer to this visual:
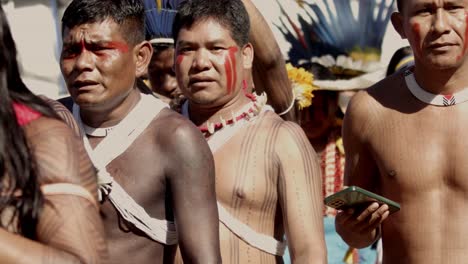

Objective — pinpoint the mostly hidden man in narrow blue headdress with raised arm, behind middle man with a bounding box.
[145,0,295,121]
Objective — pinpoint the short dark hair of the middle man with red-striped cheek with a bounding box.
[172,0,250,47]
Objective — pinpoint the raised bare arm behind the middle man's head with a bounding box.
[242,0,296,121]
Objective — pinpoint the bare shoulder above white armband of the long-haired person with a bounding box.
[24,117,96,189]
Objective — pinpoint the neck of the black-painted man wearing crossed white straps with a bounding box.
[80,89,141,128]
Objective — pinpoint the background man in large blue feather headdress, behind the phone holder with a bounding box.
[278,0,394,264]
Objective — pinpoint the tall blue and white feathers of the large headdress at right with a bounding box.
[277,0,395,64]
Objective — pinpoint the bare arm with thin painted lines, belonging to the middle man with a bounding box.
[276,122,327,263]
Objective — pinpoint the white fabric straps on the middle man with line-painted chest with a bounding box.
[182,101,287,256]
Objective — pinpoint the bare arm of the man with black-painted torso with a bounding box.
[166,119,221,264]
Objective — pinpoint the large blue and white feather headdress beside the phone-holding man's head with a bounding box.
[277,0,395,90]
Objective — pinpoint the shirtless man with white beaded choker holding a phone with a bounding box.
[336,0,468,264]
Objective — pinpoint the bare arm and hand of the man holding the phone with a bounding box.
[336,92,388,248]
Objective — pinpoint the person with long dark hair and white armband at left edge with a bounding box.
[0,6,107,264]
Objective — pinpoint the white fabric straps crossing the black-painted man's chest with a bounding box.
[73,94,177,245]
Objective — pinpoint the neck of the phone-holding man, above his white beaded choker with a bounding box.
[414,60,468,95]
